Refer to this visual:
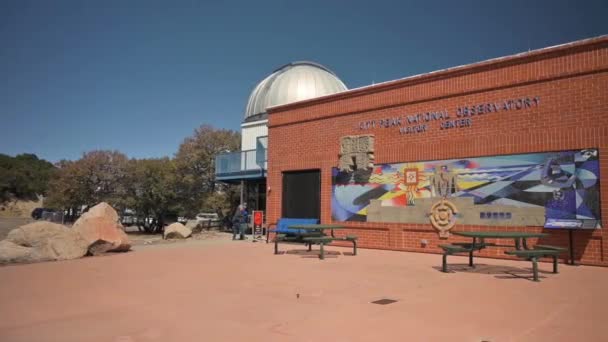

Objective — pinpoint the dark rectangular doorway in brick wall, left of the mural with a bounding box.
[282,170,321,219]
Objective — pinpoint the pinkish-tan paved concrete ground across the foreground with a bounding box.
[0,239,608,342]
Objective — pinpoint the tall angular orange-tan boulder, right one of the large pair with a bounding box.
[72,202,131,255]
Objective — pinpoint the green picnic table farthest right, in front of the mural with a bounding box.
[439,231,566,281]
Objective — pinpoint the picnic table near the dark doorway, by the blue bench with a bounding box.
[274,224,357,260]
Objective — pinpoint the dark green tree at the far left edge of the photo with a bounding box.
[0,153,56,202]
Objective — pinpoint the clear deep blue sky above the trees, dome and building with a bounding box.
[0,0,608,161]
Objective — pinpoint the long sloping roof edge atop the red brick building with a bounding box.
[266,35,608,115]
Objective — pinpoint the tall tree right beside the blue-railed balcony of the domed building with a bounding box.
[175,125,241,215]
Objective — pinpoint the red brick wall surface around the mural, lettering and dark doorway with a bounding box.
[267,37,608,266]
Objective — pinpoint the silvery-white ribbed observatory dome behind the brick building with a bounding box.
[245,62,348,121]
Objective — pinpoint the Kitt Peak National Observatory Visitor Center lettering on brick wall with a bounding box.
[358,96,540,134]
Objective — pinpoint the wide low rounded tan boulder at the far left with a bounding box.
[2,221,89,262]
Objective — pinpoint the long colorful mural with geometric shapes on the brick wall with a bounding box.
[332,149,600,228]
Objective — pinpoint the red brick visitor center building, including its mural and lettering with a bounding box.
[267,36,608,266]
